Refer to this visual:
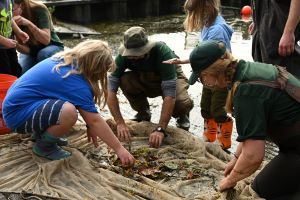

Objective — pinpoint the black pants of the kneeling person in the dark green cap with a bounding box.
[252,122,300,200]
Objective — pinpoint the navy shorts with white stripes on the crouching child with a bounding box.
[15,99,66,134]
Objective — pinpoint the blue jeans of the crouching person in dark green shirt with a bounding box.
[19,45,64,74]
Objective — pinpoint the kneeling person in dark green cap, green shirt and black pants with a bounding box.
[190,41,300,200]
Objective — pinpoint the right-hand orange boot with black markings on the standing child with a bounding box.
[218,118,233,150]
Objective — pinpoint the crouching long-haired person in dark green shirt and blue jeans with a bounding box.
[14,0,64,73]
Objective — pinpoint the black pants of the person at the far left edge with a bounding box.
[0,49,22,77]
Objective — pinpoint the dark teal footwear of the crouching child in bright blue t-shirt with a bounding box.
[32,131,71,160]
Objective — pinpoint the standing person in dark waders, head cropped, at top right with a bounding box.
[249,0,300,78]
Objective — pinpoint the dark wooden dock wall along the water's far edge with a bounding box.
[42,0,249,24]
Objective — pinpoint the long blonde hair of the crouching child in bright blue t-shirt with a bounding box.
[54,40,115,107]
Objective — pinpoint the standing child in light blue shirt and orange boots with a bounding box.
[182,0,233,149]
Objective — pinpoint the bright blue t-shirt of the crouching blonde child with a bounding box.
[2,58,97,129]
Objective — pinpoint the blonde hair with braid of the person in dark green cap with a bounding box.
[201,50,240,114]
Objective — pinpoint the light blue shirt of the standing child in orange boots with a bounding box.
[200,15,233,51]
